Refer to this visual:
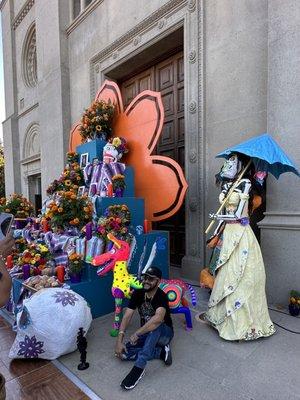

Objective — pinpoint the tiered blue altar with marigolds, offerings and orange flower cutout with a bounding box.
[4,81,186,338]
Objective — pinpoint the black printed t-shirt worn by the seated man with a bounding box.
[128,288,173,328]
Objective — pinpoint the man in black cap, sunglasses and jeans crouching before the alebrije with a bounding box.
[115,267,174,390]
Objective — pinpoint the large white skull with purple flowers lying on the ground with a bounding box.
[9,288,92,360]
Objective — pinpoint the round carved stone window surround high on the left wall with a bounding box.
[22,24,37,87]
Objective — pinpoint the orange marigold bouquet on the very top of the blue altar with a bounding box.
[79,100,115,142]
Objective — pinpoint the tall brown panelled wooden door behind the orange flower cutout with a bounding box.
[119,52,185,267]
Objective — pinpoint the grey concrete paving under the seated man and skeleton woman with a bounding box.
[60,286,300,400]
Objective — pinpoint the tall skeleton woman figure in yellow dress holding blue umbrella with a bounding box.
[200,134,299,340]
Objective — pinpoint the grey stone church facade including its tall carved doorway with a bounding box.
[1,0,300,303]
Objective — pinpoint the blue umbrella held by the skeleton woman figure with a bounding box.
[217,133,300,179]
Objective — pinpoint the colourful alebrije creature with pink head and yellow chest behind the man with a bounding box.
[92,233,196,336]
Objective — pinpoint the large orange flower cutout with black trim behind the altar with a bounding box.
[70,81,188,221]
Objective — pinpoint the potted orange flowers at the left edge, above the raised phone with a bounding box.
[0,193,33,229]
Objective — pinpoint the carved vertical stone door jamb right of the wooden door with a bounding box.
[182,0,205,280]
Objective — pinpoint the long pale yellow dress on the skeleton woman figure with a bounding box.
[205,188,275,340]
